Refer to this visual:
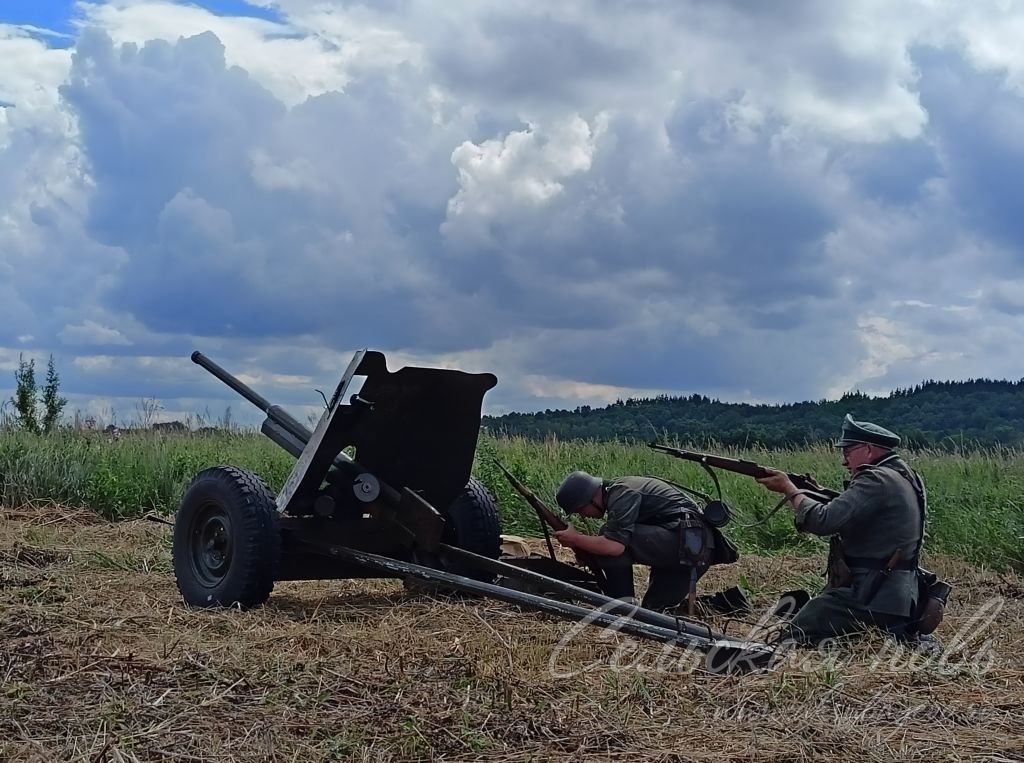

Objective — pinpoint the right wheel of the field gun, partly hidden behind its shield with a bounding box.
[404,477,502,593]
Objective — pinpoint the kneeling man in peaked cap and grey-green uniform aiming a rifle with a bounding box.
[758,414,927,644]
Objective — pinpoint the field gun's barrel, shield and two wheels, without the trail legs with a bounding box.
[174,350,500,607]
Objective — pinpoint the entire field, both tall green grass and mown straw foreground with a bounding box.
[0,432,1024,763]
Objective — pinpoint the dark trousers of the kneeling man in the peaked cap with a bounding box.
[786,588,911,645]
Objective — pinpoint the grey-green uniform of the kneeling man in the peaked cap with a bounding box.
[793,454,926,643]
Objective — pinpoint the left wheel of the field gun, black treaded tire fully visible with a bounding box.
[172,466,281,609]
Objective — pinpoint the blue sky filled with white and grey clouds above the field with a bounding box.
[0,0,1024,423]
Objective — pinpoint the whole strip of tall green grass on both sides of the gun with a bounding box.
[0,429,1024,569]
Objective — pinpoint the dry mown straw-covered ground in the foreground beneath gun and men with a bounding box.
[0,507,1024,762]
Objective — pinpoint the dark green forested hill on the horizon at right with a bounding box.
[483,379,1024,450]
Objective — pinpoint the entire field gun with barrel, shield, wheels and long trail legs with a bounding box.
[173,350,772,670]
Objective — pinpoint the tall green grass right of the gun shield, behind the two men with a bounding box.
[475,437,1024,570]
